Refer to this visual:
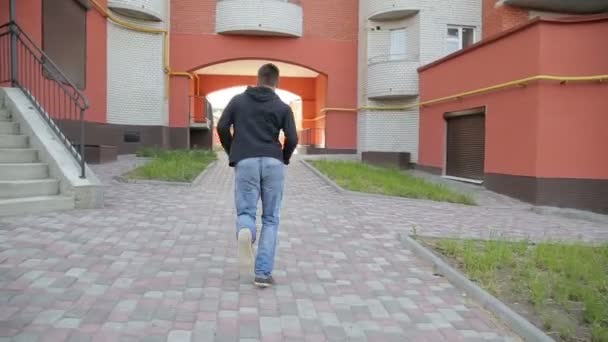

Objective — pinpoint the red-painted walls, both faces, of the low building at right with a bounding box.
[420,19,608,179]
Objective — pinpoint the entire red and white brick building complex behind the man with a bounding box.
[0,0,608,212]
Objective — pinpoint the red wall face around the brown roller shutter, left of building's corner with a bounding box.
[419,23,539,175]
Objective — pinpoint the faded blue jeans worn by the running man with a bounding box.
[234,157,285,278]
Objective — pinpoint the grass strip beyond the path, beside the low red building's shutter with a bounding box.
[312,160,475,205]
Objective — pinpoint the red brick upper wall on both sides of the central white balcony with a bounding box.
[171,0,359,41]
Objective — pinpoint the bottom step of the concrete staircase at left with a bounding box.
[0,196,74,216]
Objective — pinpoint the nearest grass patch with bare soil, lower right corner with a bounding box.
[423,239,608,342]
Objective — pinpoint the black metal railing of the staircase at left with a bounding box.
[0,21,89,178]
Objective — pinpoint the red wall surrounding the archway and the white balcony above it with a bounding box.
[170,0,358,148]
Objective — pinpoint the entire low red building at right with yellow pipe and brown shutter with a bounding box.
[419,1,608,213]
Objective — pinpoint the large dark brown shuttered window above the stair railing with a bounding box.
[42,0,87,89]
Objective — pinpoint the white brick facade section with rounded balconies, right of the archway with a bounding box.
[357,0,482,163]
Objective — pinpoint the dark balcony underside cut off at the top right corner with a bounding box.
[503,0,608,14]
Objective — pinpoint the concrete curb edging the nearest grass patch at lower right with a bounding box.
[399,234,555,342]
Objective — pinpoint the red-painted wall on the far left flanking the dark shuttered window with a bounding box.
[0,0,107,122]
